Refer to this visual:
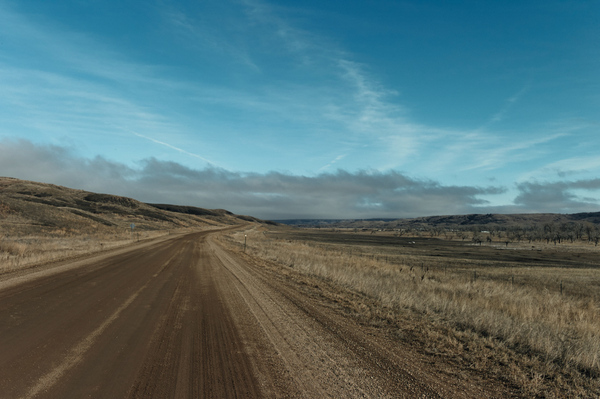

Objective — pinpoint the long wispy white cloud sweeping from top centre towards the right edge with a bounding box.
[159,0,596,181]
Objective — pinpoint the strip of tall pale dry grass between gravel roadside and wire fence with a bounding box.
[233,232,600,377]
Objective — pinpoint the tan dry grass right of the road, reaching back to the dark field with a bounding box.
[224,230,600,397]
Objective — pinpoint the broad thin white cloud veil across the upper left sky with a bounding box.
[0,2,227,167]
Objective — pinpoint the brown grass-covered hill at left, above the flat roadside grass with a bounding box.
[0,177,270,237]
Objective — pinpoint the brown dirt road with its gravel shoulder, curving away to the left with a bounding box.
[0,232,510,399]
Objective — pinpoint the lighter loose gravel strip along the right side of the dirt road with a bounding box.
[206,238,442,398]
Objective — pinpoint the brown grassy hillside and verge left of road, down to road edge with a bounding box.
[0,177,258,273]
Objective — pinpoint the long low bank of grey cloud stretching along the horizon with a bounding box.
[0,140,600,219]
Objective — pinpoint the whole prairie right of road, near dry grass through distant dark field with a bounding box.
[229,229,600,397]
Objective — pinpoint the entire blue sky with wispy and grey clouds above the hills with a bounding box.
[0,0,600,219]
